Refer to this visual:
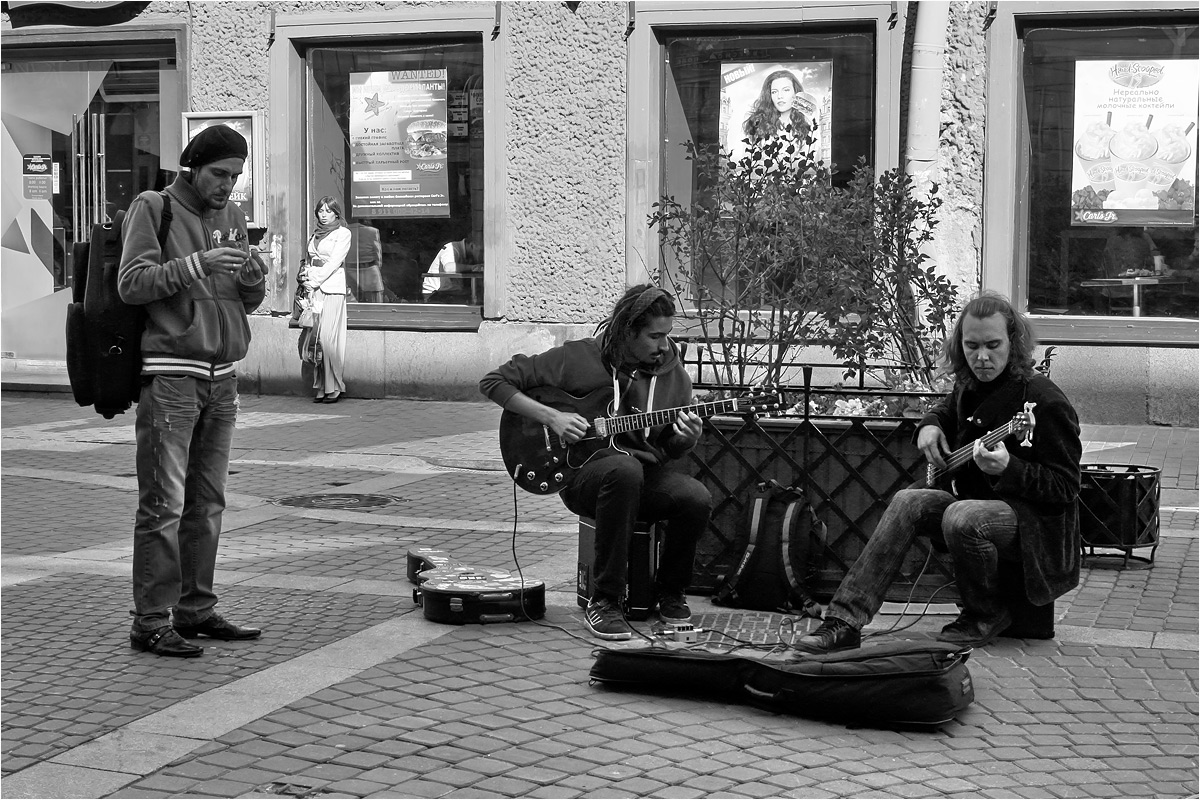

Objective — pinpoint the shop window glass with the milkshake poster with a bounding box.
[1021,21,1200,319]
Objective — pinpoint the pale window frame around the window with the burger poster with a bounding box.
[268,9,510,331]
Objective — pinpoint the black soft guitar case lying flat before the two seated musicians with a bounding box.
[590,640,974,728]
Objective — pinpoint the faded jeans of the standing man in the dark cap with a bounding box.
[133,375,238,631]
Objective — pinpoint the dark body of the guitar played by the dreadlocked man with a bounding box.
[500,386,612,494]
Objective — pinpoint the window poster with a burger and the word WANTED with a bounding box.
[350,68,458,217]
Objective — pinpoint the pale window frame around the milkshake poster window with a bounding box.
[982,0,1200,348]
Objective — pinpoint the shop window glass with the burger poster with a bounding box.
[306,35,486,314]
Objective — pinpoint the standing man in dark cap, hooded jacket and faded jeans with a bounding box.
[118,125,266,658]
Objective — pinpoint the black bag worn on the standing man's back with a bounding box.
[67,192,174,420]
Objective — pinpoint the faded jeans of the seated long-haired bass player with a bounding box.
[826,489,1021,628]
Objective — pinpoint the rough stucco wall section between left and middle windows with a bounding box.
[501,2,625,323]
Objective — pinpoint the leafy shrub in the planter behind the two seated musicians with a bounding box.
[649,138,958,407]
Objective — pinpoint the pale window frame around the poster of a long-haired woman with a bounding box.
[625,0,906,285]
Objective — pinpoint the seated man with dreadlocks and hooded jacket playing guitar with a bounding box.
[479,284,713,640]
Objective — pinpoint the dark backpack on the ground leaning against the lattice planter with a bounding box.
[713,481,824,618]
